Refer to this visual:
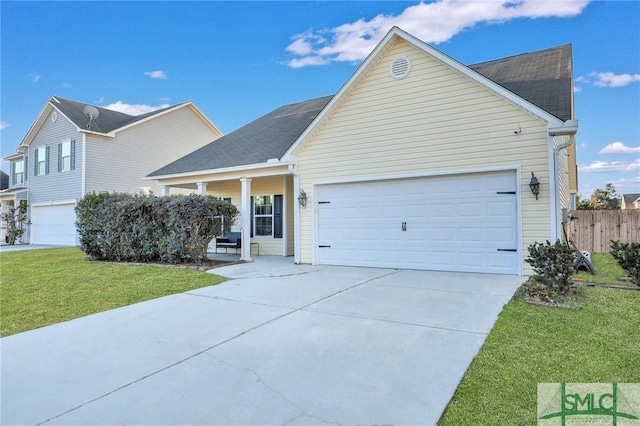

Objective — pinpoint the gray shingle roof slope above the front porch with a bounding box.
[149,96,333,176]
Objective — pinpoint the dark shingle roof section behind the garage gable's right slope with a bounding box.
[469,44,573,121]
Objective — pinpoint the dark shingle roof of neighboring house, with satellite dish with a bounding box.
[51,96,173,133]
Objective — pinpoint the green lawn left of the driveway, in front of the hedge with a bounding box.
[0,248,225,337]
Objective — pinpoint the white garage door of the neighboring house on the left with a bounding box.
[31,204,76,246]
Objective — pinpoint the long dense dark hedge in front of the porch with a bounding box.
[76,193,238,263]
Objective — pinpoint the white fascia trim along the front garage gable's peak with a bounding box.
[282,27,564,160]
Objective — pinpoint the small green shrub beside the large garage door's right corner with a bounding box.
[525,240,574,295]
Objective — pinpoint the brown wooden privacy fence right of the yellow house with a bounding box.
[566,210,640,253]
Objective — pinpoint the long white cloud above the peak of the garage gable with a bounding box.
[286,0,589,68]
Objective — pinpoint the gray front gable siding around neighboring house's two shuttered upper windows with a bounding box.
[26,109,82,204]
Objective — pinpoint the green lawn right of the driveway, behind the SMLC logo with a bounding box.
[439,287,640,426]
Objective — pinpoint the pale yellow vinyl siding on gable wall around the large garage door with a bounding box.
[297,40,550,272]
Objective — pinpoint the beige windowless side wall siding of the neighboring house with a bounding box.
[85,106,219,194]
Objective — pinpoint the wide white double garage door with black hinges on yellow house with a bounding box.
[317,171,520,274]
